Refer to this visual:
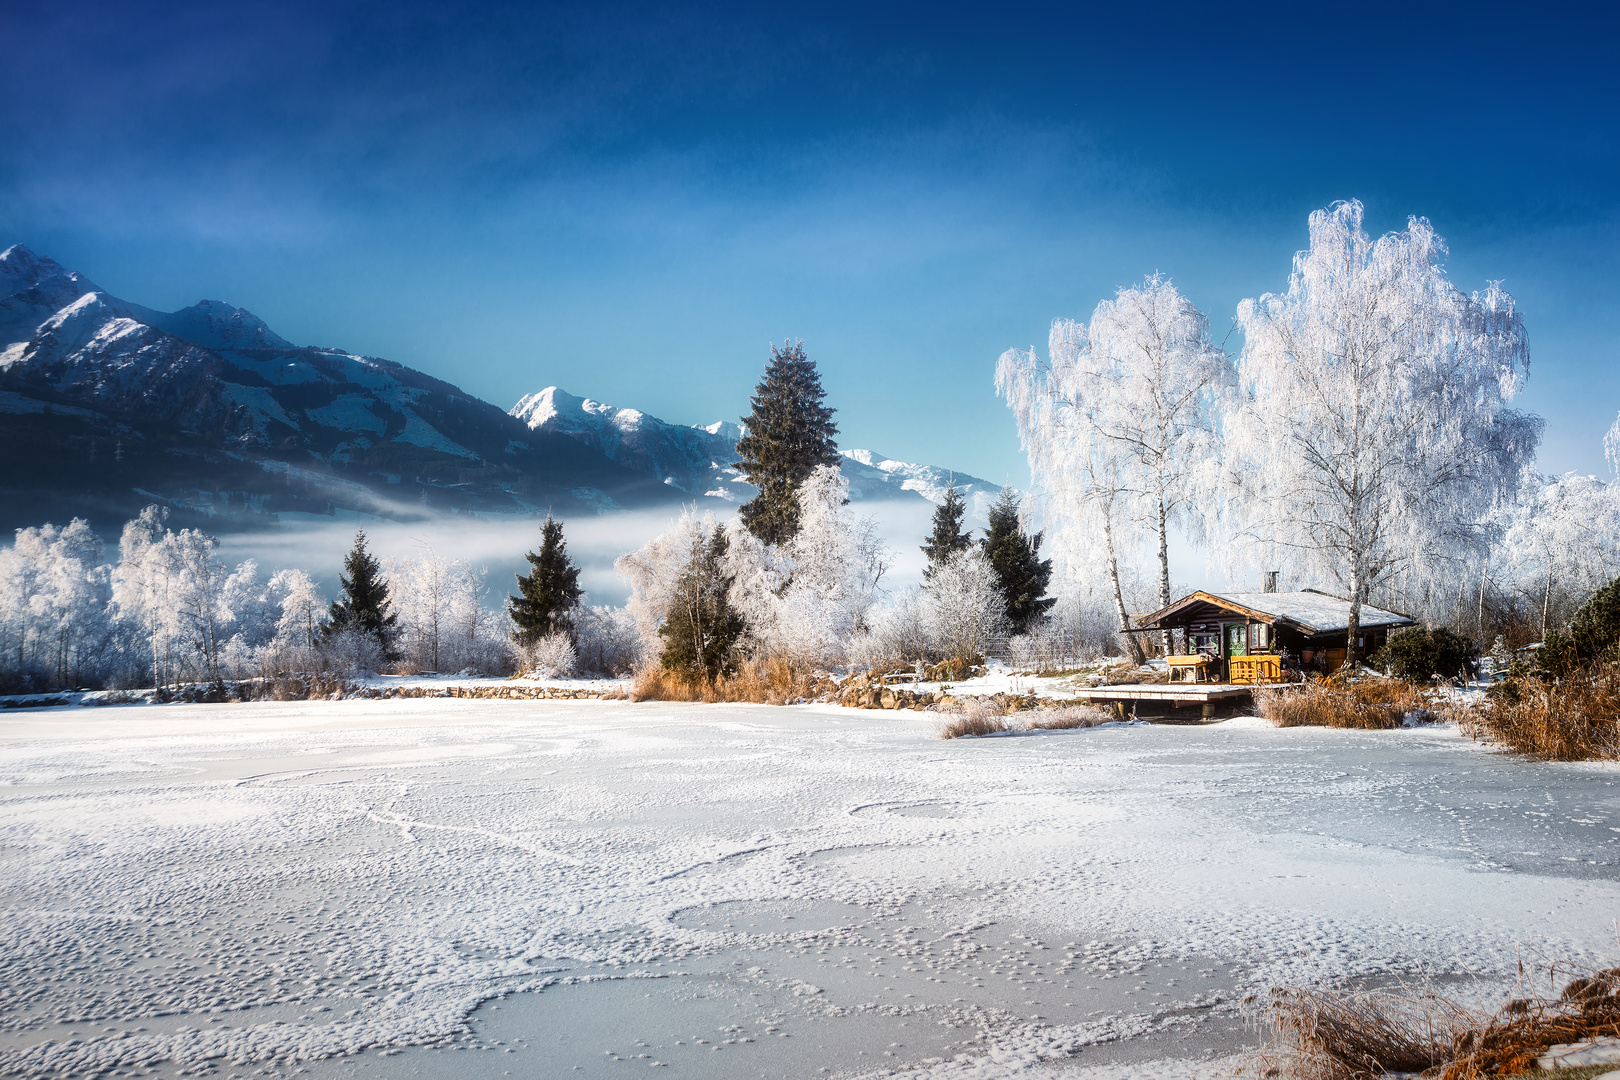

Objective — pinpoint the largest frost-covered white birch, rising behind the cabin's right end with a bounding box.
[1226,202,1541,662]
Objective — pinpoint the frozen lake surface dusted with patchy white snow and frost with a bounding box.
[0,699,1620,1080]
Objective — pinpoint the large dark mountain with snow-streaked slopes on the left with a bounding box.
[0,244,674,526]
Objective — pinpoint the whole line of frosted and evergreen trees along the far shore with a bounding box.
[0,202,1594,687]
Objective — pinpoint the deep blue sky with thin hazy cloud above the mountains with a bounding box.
[0,0,1620,483]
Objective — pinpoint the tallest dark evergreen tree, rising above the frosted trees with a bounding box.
[737,342,839,544]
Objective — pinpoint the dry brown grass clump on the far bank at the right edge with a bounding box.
[1461,665,1620,761]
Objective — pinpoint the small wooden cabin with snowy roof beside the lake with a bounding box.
[1137,589,1413,683]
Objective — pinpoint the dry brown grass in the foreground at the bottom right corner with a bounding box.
[1243,968,1620,1080]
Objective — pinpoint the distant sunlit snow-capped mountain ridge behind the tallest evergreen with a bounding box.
[512,387,1000,523]
